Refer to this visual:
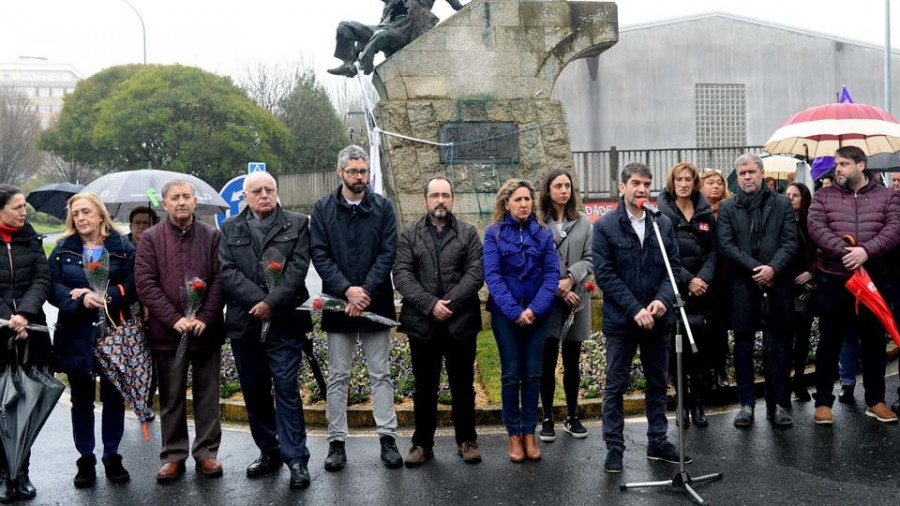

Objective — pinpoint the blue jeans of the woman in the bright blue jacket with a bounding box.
[491,315,550,436]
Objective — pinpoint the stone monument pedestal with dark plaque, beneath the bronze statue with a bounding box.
[373,0,618,225]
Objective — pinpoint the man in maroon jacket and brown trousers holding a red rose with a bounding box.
[134,179,225,483]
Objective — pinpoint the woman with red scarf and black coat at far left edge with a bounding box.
[0,184,52,503]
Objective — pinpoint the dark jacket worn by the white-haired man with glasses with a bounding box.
[219,206,312,341]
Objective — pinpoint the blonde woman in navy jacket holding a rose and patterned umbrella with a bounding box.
[50,192,137,488]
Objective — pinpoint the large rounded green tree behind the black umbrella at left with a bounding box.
[41,65,292,183]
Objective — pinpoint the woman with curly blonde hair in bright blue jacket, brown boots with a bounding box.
[484,179,559,462]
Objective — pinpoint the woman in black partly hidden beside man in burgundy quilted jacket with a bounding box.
[782,183,816,405]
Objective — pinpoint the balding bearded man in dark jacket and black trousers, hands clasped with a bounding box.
[394,175,484,467]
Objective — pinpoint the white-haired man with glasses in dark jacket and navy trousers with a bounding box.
[219,172,312,489]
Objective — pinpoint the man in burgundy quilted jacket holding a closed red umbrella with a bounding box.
[808,146,900,425]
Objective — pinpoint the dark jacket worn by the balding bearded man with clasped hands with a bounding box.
[394,214,484,339]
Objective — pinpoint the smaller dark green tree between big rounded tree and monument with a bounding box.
[277,68,349,171]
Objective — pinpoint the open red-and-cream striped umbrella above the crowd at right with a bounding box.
[764,103,900,159]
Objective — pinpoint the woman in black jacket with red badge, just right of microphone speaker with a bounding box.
[659,162,716,427]
